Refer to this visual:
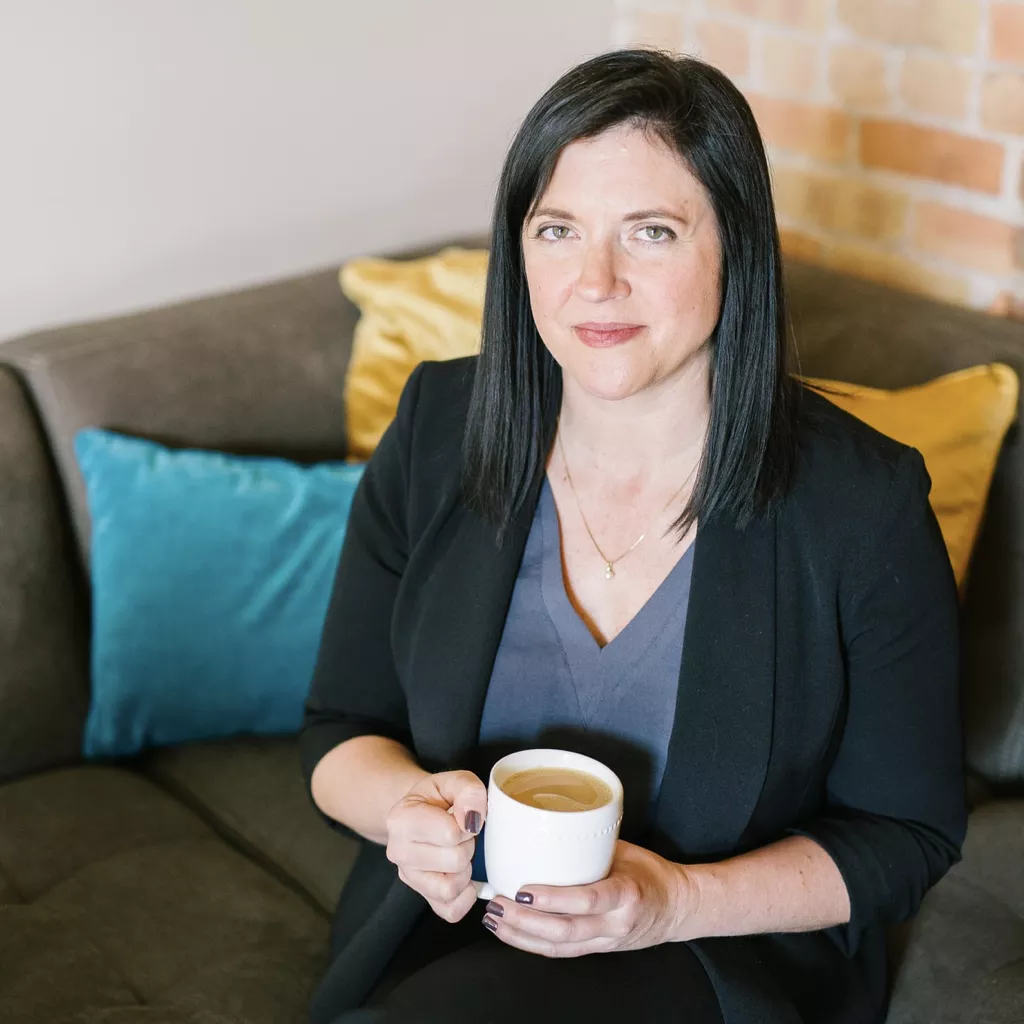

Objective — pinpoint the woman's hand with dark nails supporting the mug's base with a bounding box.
[484,840,697,956]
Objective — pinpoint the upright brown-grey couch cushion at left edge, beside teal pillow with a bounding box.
[0,367,89,780]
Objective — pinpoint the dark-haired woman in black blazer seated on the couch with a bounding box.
[301,50,965,1024]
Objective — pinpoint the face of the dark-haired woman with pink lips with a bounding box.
[522,127,721,399]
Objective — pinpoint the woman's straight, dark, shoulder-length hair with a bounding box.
[462,49,798,544]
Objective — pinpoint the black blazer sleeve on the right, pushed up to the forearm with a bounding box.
[792,449,967,955]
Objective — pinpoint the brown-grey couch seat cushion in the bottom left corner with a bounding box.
[0,766,328,1024]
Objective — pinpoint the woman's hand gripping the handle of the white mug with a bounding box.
[387,771,487,924]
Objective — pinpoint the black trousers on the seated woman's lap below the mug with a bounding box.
[334,903,723,1024]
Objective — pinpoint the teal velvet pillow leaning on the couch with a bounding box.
[75,429,362,758]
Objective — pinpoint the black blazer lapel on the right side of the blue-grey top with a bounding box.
[652,520,775,860]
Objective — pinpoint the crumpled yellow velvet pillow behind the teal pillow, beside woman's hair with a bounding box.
[340,248,487,460]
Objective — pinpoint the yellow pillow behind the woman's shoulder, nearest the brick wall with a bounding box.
[807,362,1018,594]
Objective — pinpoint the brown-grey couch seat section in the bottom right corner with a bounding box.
[887,801,1024,1024]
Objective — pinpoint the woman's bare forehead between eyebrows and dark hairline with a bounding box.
[544,125,703,200]
